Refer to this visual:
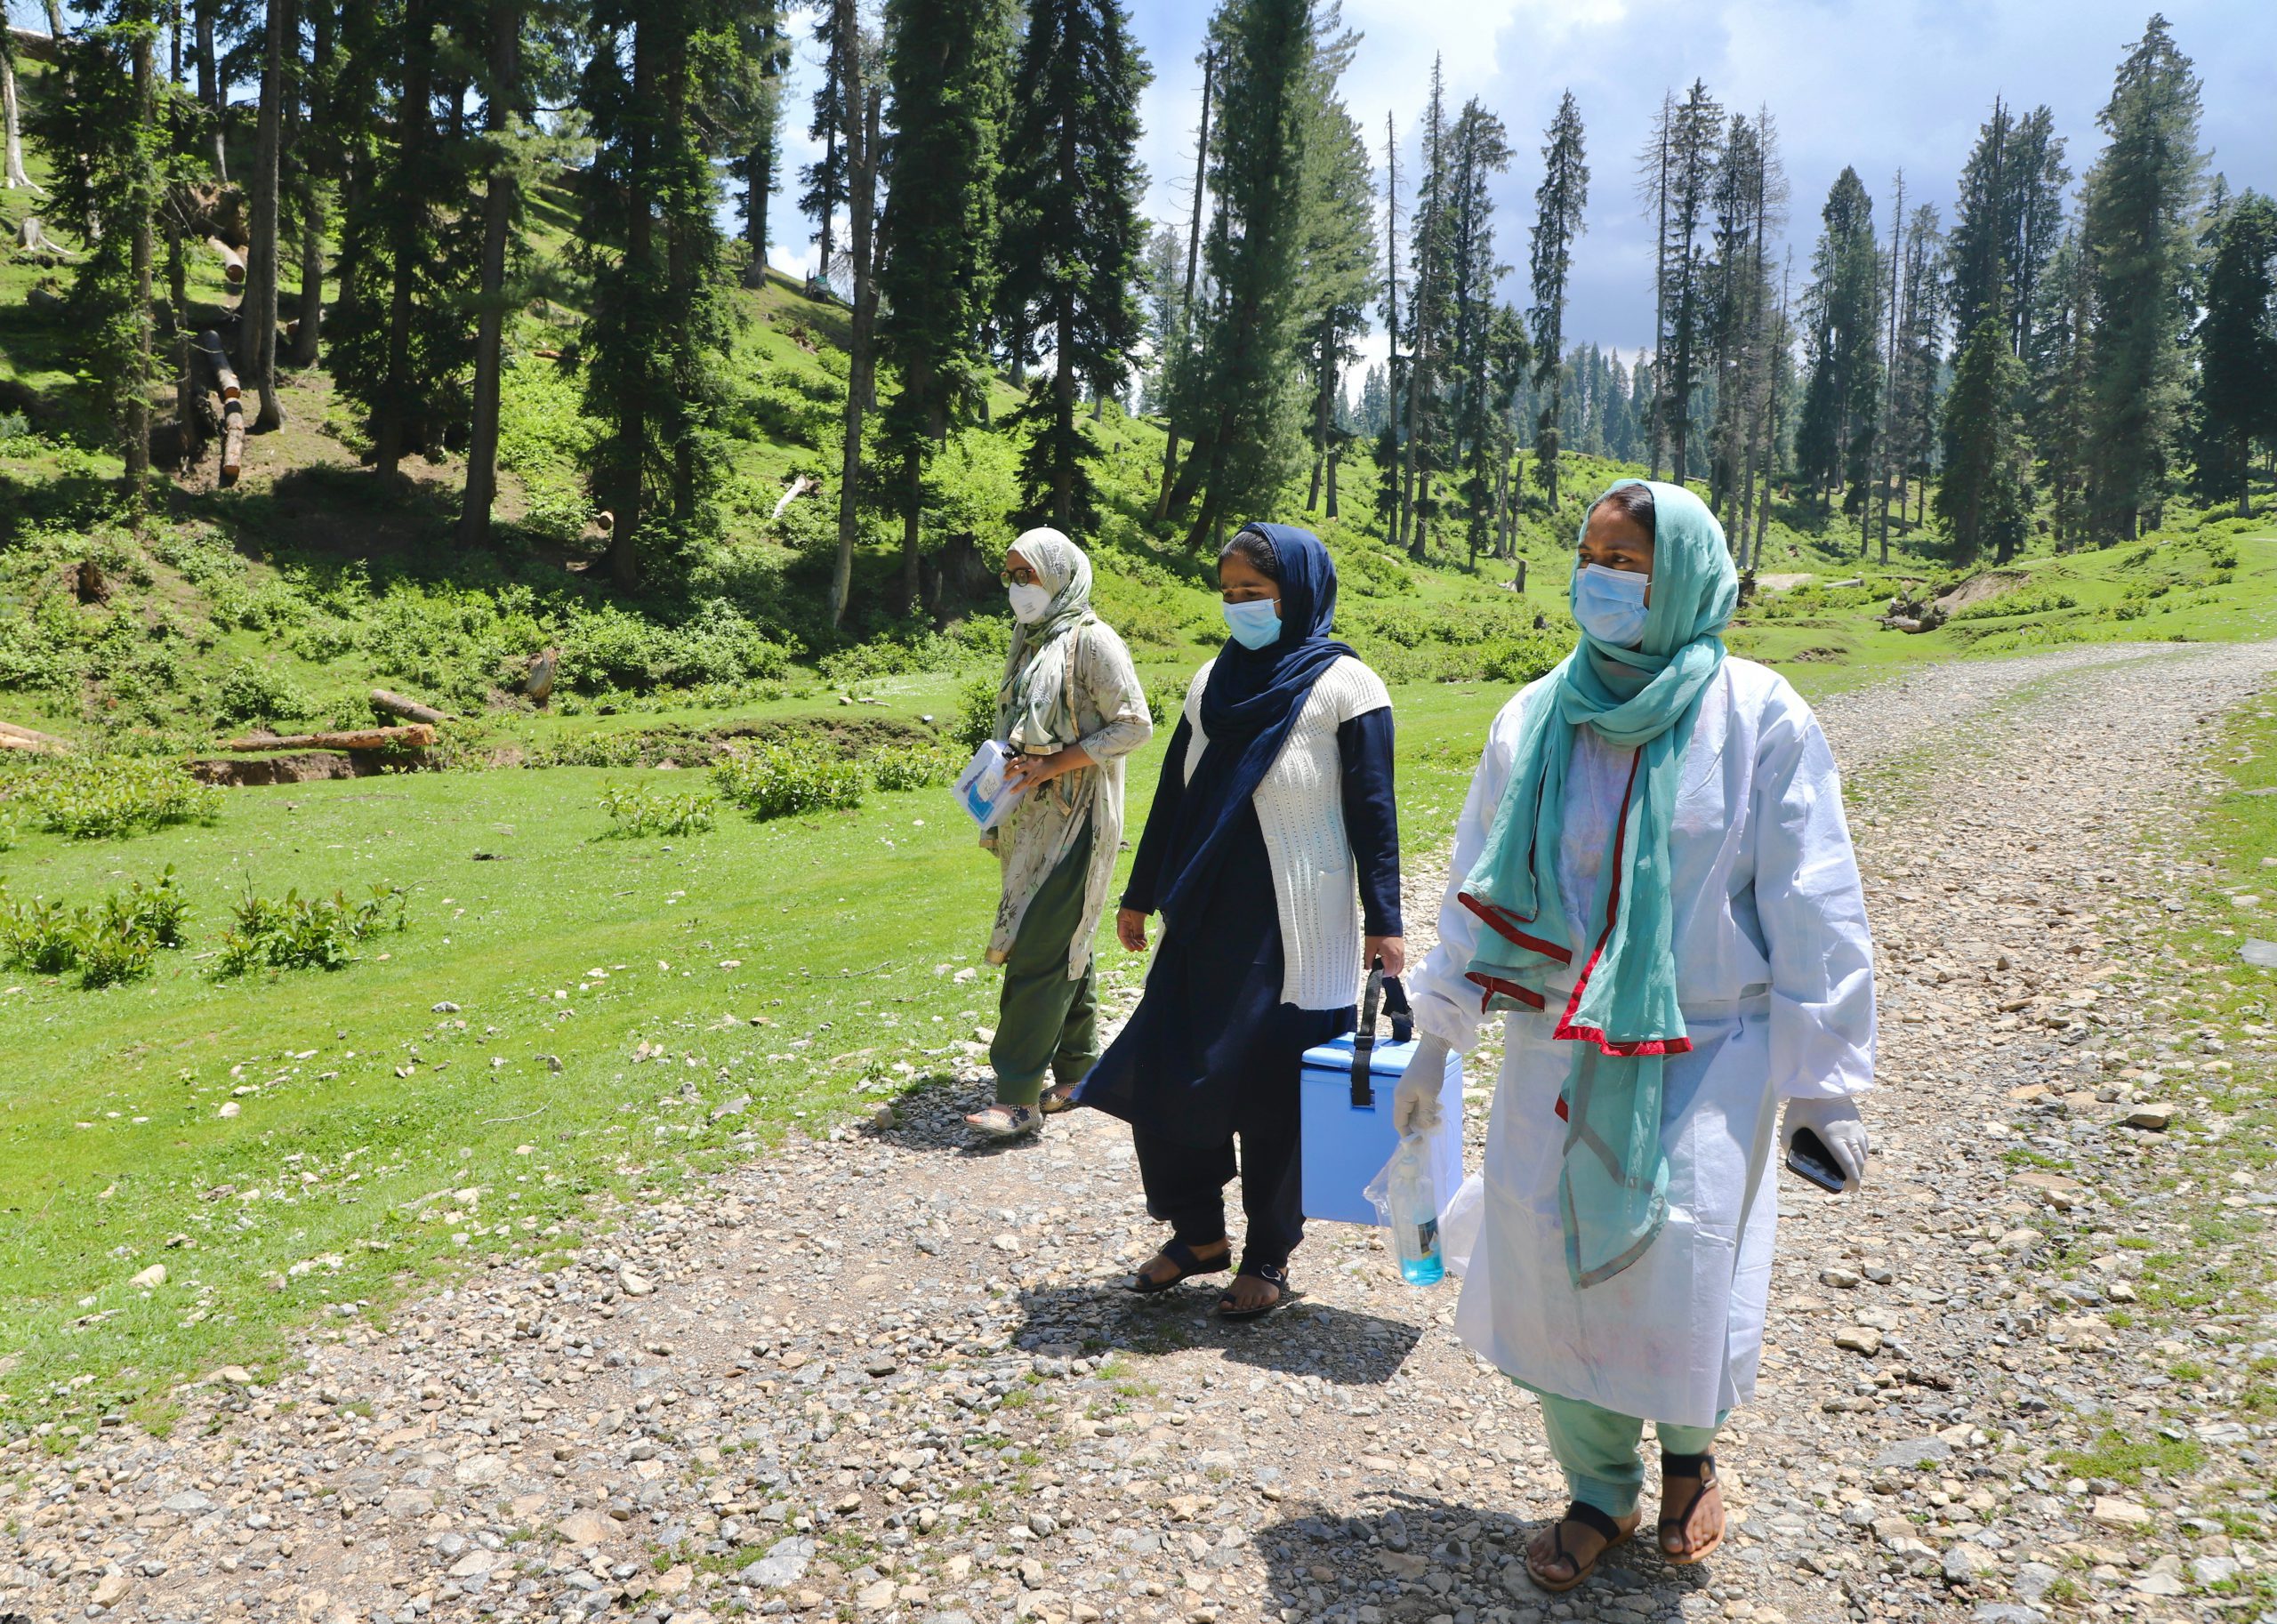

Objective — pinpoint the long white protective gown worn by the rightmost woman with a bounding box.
[1410,658,1874,1426]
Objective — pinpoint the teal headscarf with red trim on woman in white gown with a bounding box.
[1462,478,1740,1287]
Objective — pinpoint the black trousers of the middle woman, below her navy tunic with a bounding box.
[1131,1048,1305,1274]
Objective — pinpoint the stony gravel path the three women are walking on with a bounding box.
[13,647,2277,1624]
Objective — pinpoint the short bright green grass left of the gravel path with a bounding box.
[0,686,1505,1421]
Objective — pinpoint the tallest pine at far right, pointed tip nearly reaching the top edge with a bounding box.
[2083,16,2204,540]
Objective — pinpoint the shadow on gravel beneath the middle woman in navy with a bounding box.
[1016,1278,1423,1387]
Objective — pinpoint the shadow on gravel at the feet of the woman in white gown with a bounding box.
[1250,1476,1728,1624]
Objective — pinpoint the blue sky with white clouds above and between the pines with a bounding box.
[769,0,2277,366]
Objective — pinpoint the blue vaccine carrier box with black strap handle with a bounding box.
[1298,970,1462,1226]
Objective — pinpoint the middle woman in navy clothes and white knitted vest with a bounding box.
[1074,524,1405,1319]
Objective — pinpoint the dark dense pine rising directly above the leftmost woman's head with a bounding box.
[1000,0,1147,531]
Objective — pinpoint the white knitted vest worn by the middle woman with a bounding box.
[1184,656,1391,1009]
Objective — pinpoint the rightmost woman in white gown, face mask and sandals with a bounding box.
[1396,480,1874,1590]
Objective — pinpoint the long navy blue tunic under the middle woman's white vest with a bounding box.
[1077,708,1403,1146]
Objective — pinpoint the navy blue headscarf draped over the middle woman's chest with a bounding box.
[1156,524,1353,925]
